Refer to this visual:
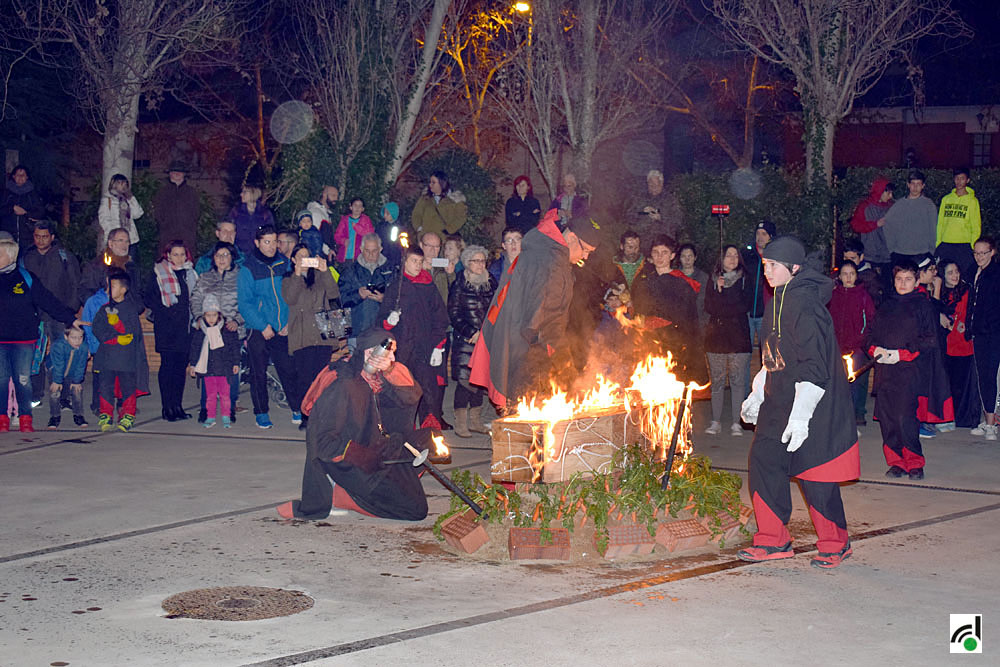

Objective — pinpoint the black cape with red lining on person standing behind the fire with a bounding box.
[470,211,573,406]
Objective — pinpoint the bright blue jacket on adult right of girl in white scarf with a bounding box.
[236,248,292,333]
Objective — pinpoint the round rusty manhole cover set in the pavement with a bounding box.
[163,586,313,621]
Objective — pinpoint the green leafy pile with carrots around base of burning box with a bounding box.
[434,445,743,552]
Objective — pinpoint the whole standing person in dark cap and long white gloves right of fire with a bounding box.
[738,236,861,569]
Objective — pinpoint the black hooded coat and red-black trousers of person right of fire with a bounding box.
[750,267,861,553]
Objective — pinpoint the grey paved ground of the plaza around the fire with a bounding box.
[0,383,1000,667]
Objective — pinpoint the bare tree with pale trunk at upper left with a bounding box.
[14,0,236,185]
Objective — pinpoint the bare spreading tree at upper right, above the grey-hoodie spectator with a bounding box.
[712,0,969,185]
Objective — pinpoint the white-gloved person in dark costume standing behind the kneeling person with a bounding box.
[378,246,451,430]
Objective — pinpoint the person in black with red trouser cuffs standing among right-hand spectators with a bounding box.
[868,262,954,480]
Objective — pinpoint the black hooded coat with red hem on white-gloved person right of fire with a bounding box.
[757,267,861,482]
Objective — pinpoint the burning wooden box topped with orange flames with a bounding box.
[492,355,701,482]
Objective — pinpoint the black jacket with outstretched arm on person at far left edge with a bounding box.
[0,262,76,343]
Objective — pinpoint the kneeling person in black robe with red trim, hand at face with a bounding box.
[278,329,431,521]
